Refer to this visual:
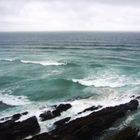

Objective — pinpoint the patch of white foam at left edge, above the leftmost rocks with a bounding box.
[0,93,30,106]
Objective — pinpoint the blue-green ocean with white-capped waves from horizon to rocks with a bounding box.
[0,32,140,130]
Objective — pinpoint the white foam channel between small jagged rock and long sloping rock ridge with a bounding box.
[40,93,131,132]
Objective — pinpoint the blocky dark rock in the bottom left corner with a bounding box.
[0,116,40,140]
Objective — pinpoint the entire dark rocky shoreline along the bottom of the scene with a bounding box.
[0,98,140,140]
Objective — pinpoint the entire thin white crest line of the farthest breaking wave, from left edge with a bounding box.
[2,59,66,66]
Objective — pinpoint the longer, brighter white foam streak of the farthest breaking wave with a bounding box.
[20,60,66,66]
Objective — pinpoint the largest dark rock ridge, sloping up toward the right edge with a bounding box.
[51,100,138,140]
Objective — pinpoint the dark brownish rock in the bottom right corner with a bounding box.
[109,127,138,140]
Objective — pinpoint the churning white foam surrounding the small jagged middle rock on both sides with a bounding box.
[0,91,136,133]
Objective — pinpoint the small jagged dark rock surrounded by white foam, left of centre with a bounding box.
[39,104,72,121]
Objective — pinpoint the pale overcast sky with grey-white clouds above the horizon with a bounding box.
[0,0,140,31]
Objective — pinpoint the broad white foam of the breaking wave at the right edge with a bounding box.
[72,74,140,88]
